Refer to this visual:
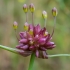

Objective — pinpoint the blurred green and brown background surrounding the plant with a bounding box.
[0,0,70,70]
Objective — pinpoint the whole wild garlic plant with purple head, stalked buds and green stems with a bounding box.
[0,3,70,70]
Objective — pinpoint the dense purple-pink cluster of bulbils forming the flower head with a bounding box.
[13,4,55,58]
